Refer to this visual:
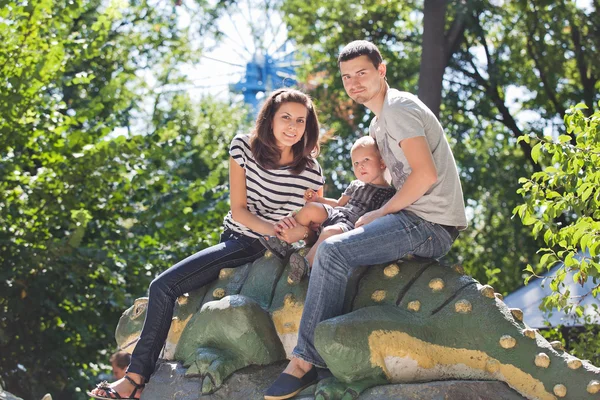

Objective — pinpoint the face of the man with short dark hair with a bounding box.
[340,56,385,104]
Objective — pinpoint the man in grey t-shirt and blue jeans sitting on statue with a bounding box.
[265,40,467,400]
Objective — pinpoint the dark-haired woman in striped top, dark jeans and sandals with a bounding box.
[87,88,323,400]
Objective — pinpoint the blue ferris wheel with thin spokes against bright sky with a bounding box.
[197,0,298,115]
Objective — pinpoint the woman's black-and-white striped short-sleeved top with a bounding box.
[223,135,325,238]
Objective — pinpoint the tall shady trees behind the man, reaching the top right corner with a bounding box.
[282,0,599,293]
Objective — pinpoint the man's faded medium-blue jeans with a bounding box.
[292,211,454,368]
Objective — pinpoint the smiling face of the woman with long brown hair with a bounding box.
[271,102,308,150]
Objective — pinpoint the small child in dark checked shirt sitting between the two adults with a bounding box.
[260,136,396,282]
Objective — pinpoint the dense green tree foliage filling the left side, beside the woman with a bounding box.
[0,0,248,399]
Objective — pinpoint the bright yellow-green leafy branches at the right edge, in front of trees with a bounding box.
[514,103,600,317]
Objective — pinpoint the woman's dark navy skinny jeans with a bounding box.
[127,230,265,381]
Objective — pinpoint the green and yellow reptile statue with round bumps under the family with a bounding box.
[116,249,600,400]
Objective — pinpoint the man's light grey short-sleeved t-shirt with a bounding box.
[369,88,467,230]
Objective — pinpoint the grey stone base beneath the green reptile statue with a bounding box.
[141,362,523,400]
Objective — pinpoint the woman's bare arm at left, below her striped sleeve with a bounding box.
[229,157,275,235]
